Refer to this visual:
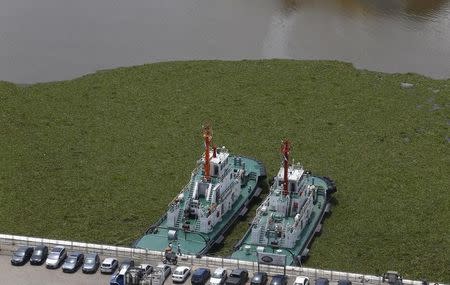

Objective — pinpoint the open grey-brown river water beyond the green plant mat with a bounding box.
[0,0,450,83]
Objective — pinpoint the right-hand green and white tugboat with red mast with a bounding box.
[231,140,336,264]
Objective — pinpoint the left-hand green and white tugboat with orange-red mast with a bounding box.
[134,125,266,255]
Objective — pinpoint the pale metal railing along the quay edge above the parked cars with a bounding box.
[0,234,442,285]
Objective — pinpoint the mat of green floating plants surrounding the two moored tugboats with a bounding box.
[0,60,450,282]
